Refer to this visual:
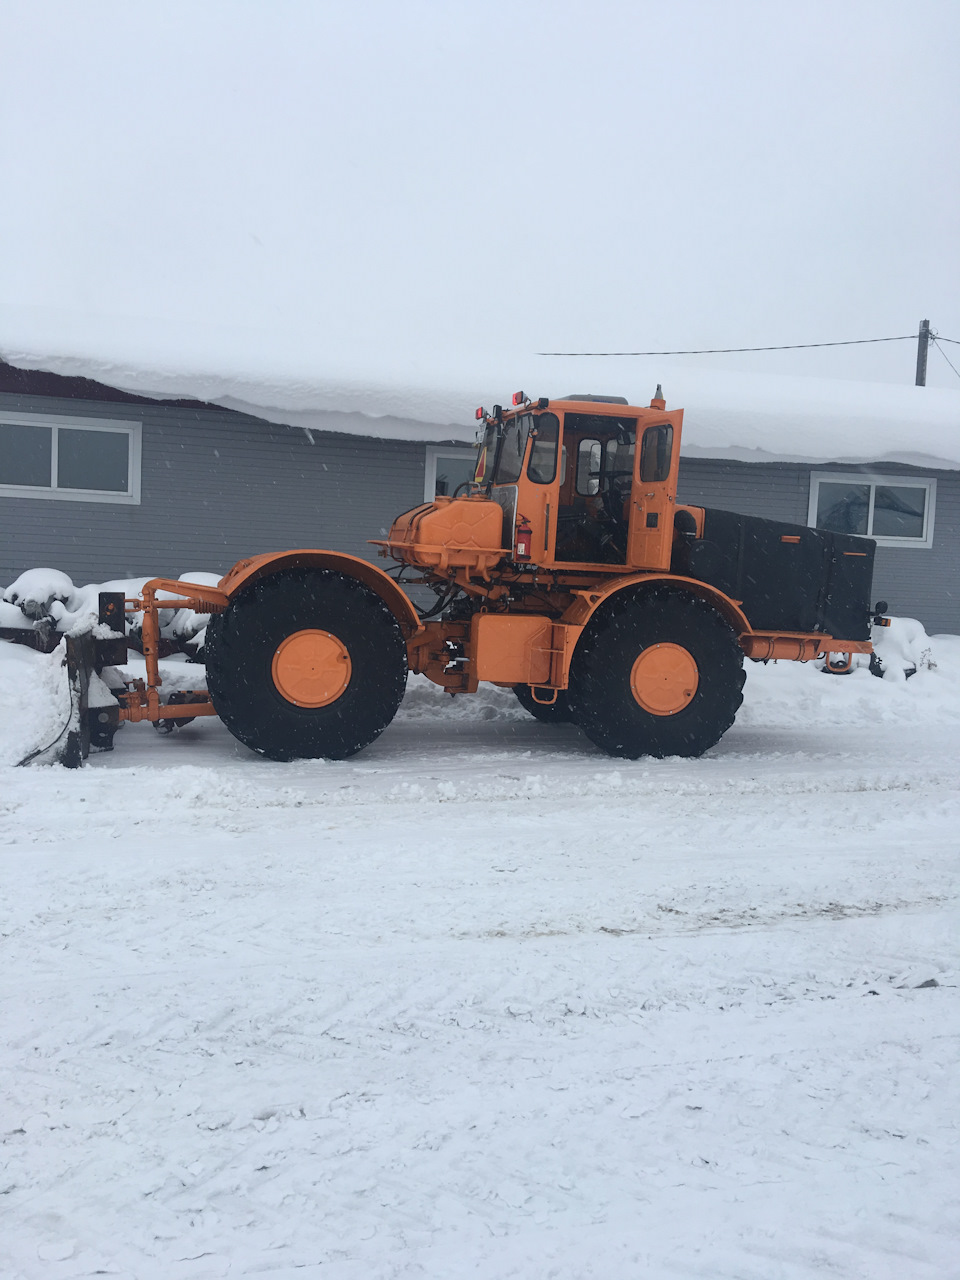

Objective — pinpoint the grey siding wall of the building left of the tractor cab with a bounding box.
[0,394,425,586]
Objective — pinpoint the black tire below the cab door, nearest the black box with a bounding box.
[570,586,745,760]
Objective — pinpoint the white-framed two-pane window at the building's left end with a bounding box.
[0,411,141,503]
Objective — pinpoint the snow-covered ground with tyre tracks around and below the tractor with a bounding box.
[0,637,960,1280]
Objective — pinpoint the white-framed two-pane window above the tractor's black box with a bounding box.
[806,471,937,548]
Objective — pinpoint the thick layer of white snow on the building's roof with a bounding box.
[3,347,960,470]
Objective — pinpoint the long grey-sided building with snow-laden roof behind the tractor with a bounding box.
[0,364,960,632]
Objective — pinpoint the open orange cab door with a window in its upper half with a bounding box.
[627,410,684,570]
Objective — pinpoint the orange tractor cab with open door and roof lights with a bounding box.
[475,388,682,571]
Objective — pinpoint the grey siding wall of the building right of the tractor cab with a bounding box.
[677,458,960,634]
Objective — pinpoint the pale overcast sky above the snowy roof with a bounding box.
[0,0,960,394]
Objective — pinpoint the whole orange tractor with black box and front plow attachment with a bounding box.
[67,387,878,760]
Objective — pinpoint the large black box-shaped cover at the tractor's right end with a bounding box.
[671,508,877,640]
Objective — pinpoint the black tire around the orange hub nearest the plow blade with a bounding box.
[204,570,407,760]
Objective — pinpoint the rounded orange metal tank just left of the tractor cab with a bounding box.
[380,494,508,577]
